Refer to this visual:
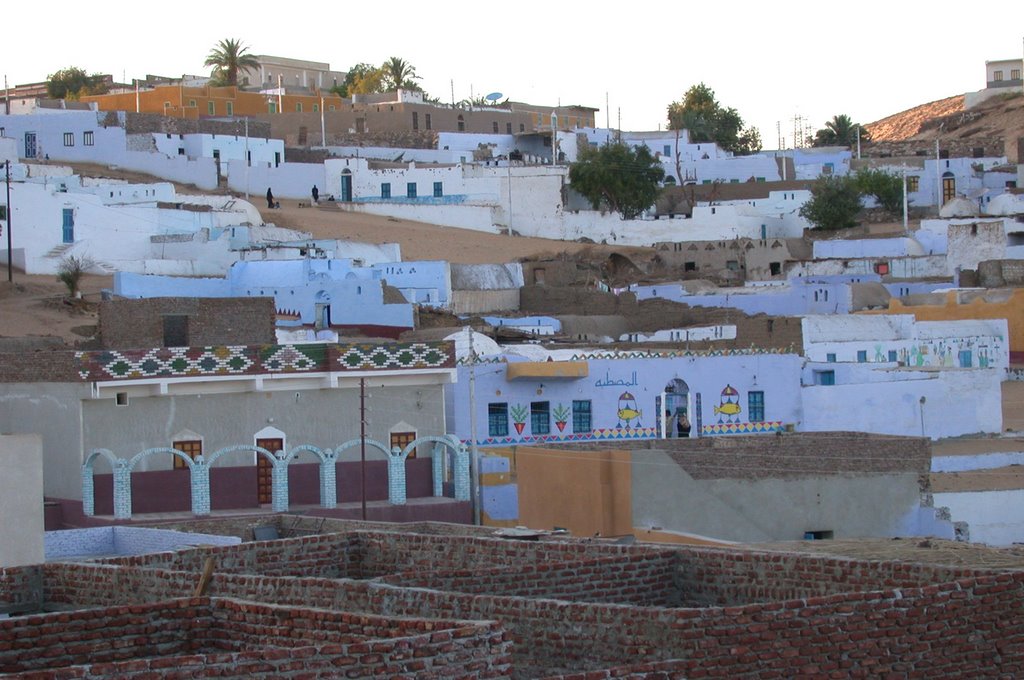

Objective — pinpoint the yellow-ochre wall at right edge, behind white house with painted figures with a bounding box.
[857,288,1024,363]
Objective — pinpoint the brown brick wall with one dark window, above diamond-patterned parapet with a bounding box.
[99,297,276,349]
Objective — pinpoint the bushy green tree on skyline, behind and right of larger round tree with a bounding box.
[669,83,761,156]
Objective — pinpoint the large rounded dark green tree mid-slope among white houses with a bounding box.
[569,142,665,219]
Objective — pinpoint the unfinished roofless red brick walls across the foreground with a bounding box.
[0,522,1024,678]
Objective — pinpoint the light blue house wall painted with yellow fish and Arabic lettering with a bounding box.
[447,352,802,445]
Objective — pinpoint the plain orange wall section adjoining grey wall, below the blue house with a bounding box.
[483,447,633,536]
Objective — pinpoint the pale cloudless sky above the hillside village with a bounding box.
[0,0,1024,148]
